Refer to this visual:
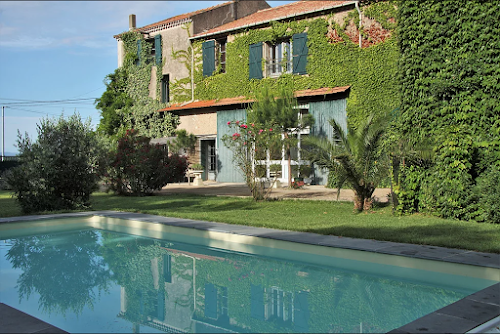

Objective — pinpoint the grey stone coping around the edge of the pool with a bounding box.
[0,211,500,333]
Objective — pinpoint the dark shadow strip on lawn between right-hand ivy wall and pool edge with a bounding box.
[304,221,500,253]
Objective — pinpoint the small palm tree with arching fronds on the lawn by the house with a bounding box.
[308,114,389,211]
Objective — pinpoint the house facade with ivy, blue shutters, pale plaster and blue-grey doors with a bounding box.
[113,1,398,184]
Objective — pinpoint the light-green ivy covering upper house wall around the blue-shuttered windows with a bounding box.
[189,2,400,130]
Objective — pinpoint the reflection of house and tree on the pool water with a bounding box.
[7,230,471,333]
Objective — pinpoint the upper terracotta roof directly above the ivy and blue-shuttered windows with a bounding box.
[191,0,356,39]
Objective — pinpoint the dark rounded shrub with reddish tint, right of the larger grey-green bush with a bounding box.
[107,130,188,196]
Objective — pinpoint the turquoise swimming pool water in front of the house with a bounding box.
[0,215,499,333]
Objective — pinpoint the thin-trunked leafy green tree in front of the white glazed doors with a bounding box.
[248,86,314,187]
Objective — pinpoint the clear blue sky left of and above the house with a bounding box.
[0,1,291,153]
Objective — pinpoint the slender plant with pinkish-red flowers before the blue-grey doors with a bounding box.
[222,120,279,200]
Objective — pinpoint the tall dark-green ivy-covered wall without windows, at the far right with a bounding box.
[399,0,500,222]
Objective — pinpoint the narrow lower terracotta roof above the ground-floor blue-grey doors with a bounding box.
[158,86,350,112]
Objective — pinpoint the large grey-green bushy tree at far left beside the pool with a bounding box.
[7,114,104,213]
